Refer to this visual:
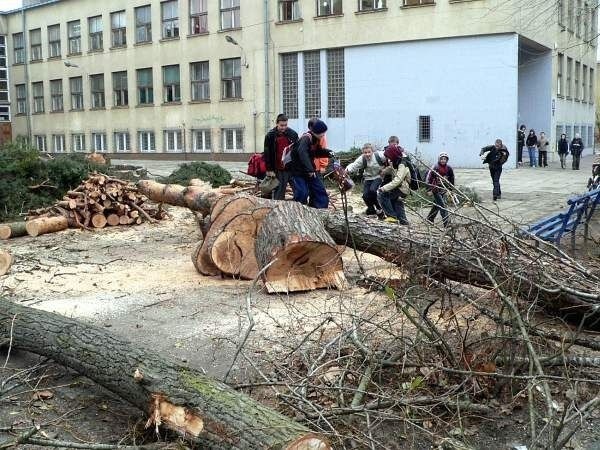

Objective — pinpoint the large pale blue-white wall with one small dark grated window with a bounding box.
[338,34,518,167]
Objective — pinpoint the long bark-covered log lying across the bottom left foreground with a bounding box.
[0,298,331,450]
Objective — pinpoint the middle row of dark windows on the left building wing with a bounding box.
[15,58,242,114]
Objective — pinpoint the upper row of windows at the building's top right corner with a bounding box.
[558,0,598,45]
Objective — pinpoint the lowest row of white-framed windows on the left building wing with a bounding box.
[33,128,244,153]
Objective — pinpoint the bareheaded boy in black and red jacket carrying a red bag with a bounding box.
[264,114,298,200]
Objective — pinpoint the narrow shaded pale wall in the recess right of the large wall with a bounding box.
[519,51,552,137]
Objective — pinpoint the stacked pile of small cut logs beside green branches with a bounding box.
[29,173,166,229]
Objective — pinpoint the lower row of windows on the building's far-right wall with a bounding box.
[556,53,596,104]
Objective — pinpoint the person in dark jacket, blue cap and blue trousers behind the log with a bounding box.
[287,120,329,208]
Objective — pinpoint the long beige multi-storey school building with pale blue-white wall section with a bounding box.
[0,0,597,167]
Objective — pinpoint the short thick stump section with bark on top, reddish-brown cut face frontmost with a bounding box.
[256,202,346,293]
